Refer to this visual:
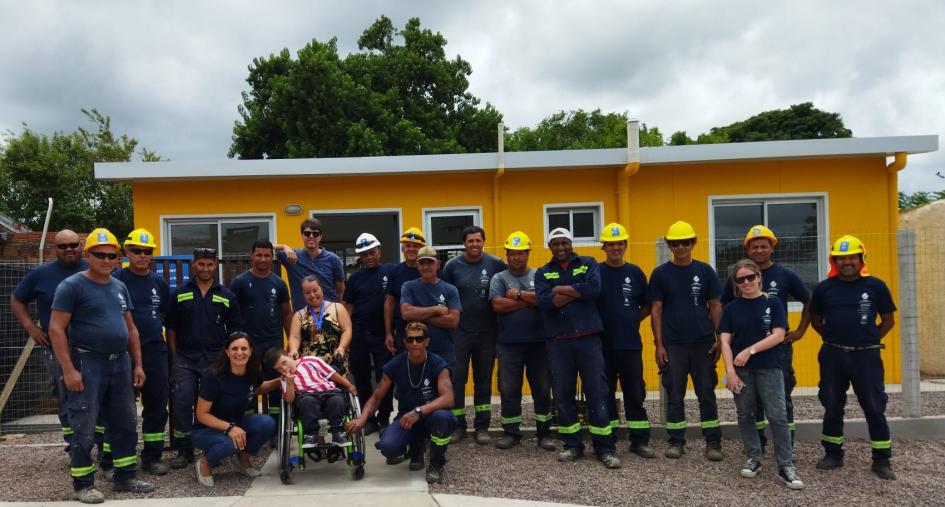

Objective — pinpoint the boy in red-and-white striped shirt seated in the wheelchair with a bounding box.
[263,347,358,449]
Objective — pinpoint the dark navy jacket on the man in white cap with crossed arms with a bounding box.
[535,252,604,338]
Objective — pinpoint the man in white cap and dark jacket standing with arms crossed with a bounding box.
[535,227,620,468]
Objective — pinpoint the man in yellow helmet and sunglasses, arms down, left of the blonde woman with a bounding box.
[648,221,723,461]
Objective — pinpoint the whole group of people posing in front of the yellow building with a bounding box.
[11,215,896,503]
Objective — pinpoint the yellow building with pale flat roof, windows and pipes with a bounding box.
[95,134,938,388]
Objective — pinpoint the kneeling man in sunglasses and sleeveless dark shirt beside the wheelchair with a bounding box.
[345,322,456,483]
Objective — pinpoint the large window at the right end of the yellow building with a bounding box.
[709,195,827,298]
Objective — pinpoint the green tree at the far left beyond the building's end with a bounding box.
[0,109,160,237]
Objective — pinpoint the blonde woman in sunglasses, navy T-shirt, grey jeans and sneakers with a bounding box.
[719,259,804,489]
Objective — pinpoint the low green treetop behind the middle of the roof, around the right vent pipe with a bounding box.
[505,109,663,151]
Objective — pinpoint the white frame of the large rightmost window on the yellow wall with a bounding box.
[708,192,830,312]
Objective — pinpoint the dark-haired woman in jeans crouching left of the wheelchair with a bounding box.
[191,332,279,486]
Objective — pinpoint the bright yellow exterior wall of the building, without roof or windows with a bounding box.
[134,157,900,389]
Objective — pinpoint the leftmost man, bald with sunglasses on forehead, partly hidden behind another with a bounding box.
[10,229,89,452]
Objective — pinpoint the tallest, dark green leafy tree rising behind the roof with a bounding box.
[229,16,502,159]
